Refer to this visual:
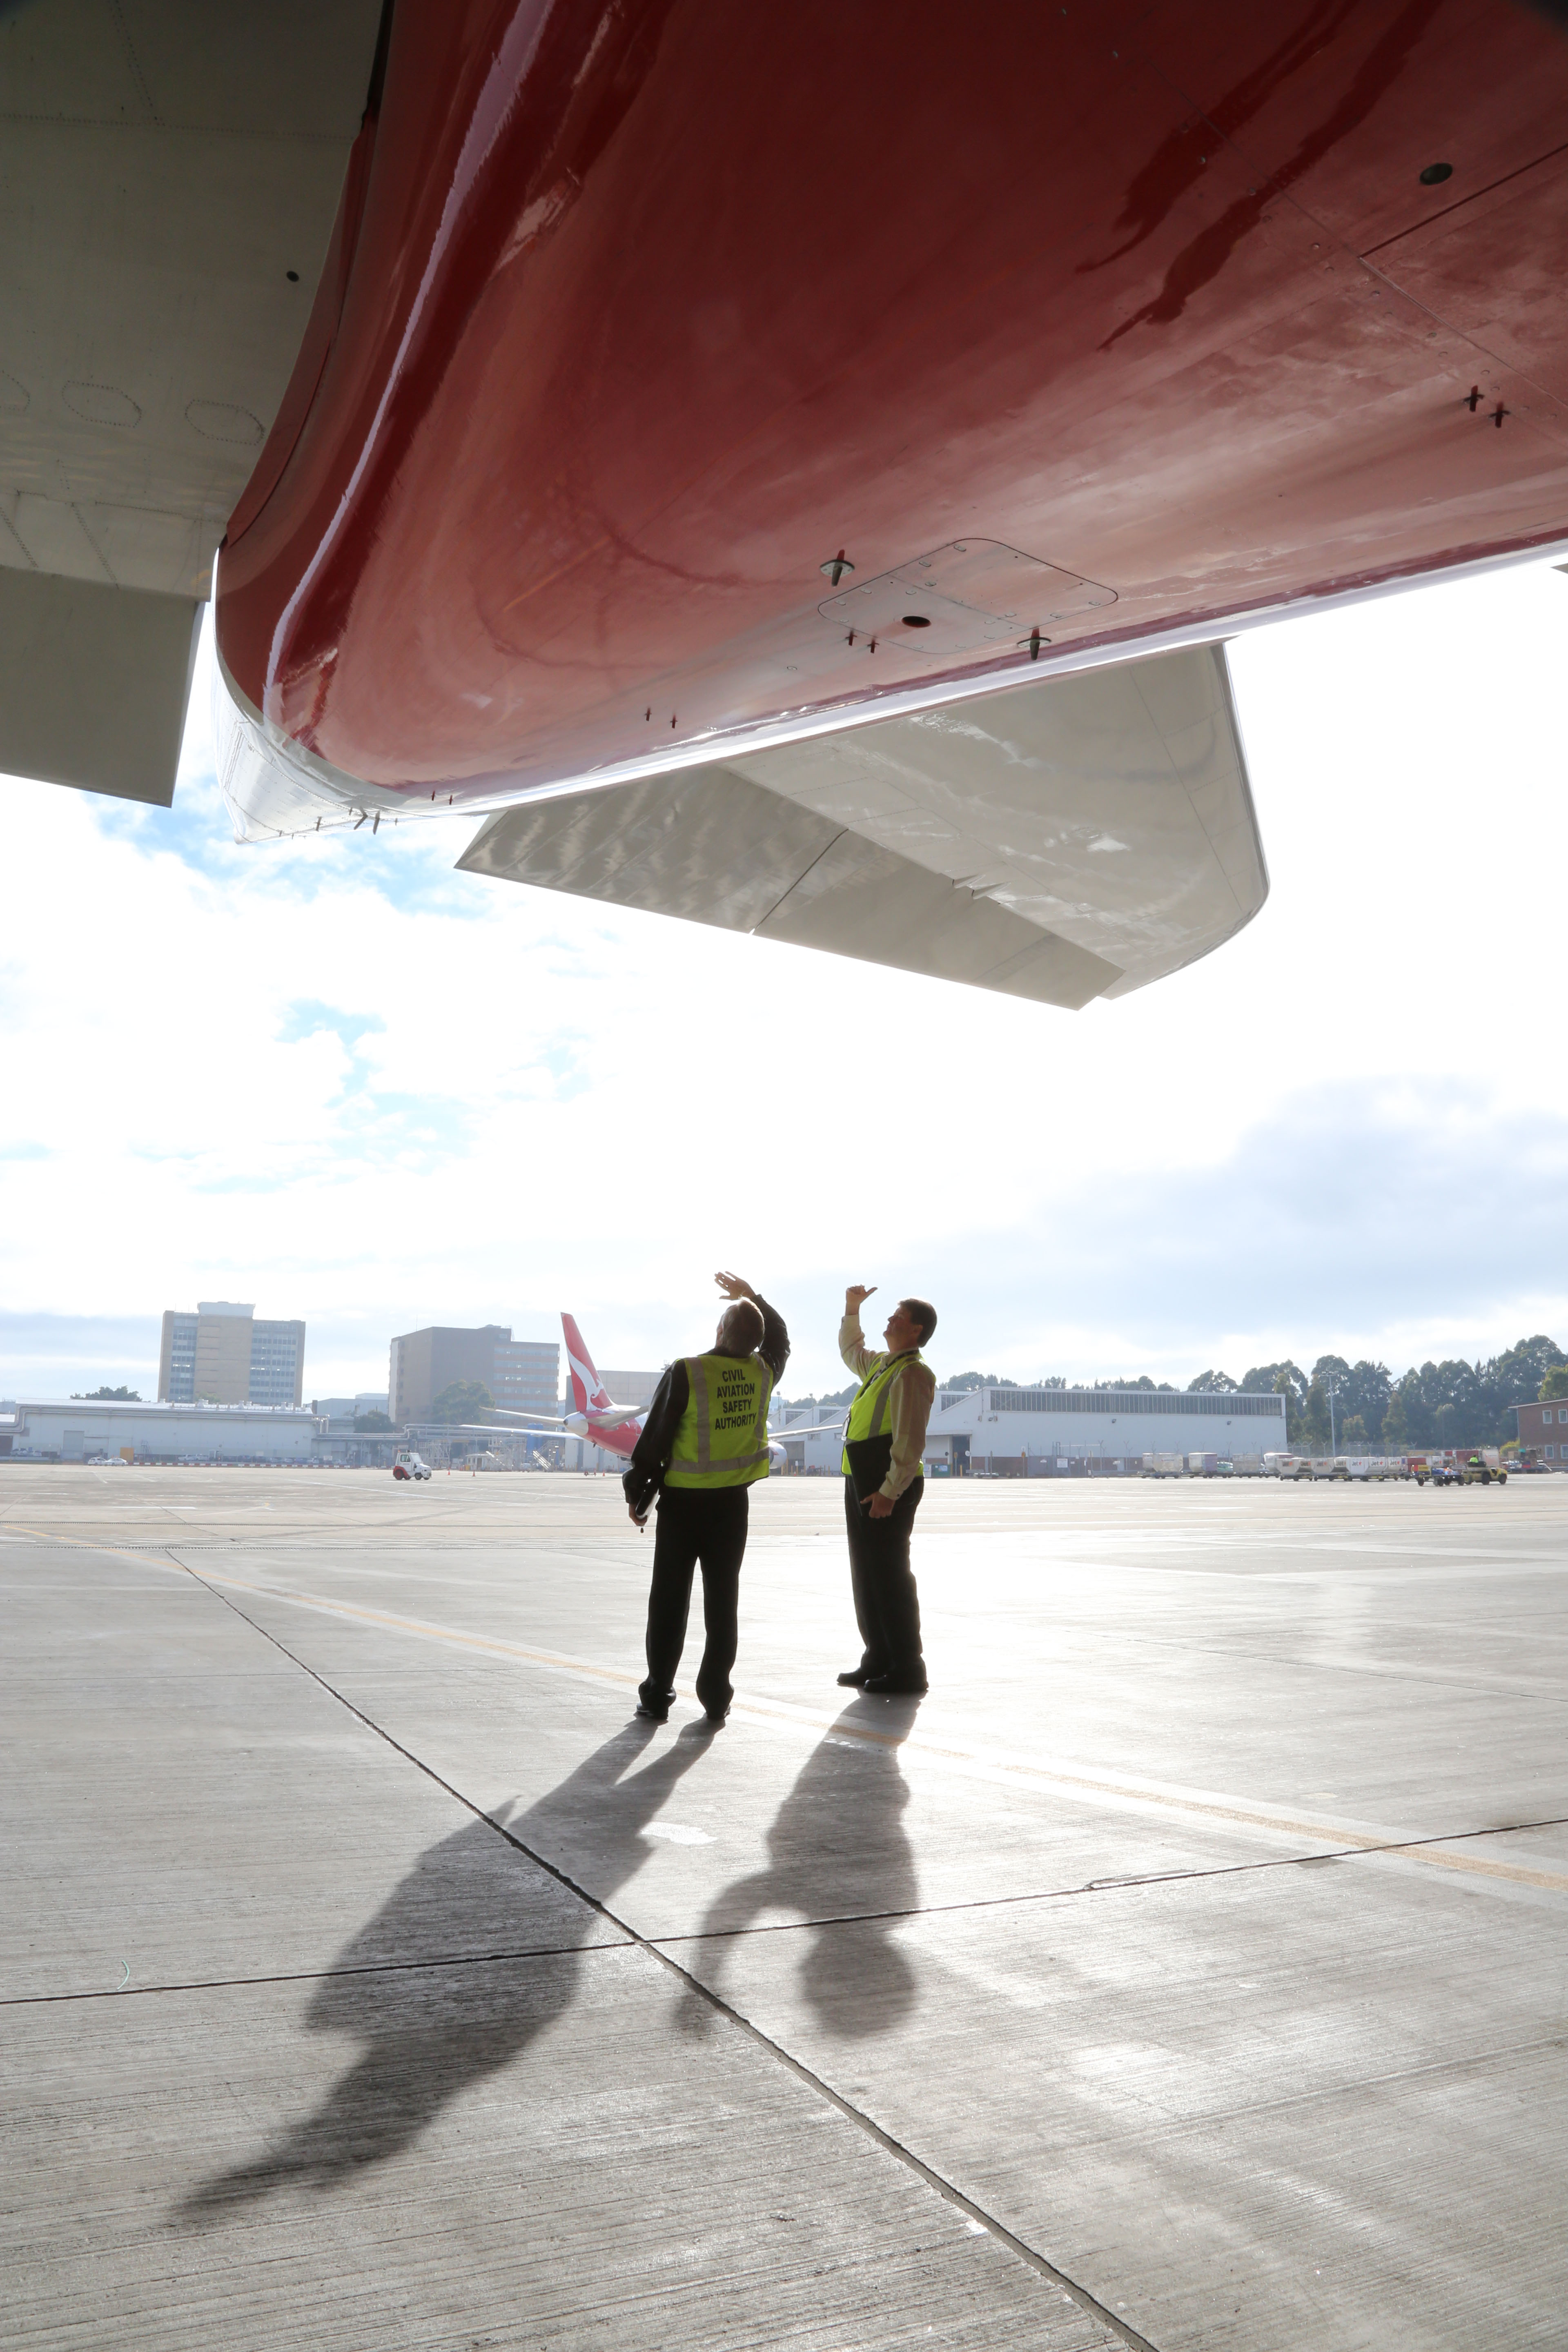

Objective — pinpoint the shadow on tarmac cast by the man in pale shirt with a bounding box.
[668,1698,919,2042]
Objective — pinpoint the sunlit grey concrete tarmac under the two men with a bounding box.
[0,1465,1568,2352]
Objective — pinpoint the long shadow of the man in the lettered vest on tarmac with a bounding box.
[176,1722,710,2223]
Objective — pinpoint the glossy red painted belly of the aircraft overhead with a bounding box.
[218,0,1568,802]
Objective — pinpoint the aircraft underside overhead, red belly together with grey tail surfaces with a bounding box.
[0,0,1568,1004]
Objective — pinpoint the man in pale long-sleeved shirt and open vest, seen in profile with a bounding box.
[839,1282,935,1693]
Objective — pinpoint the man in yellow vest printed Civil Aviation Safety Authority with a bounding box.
[621,1275,790,1724]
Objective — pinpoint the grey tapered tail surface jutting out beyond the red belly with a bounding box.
[459,644,1267,1009]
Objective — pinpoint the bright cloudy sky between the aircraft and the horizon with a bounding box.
[0,567,1568,1397]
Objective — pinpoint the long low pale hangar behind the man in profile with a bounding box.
[773,1385,1286,1477]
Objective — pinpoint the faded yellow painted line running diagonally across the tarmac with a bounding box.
[15,1538,1568,1893]
